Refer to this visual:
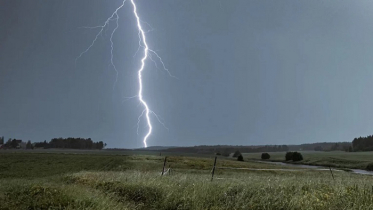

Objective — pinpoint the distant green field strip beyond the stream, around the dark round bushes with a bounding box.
[243,151,373,169]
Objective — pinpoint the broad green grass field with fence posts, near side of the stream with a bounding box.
[0,151,373,210]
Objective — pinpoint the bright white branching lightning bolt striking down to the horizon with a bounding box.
[75,0,173,148]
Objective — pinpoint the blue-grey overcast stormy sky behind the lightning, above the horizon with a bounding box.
[0,0,373,148]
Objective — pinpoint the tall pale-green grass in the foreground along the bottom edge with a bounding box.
[0,170,373,209]
